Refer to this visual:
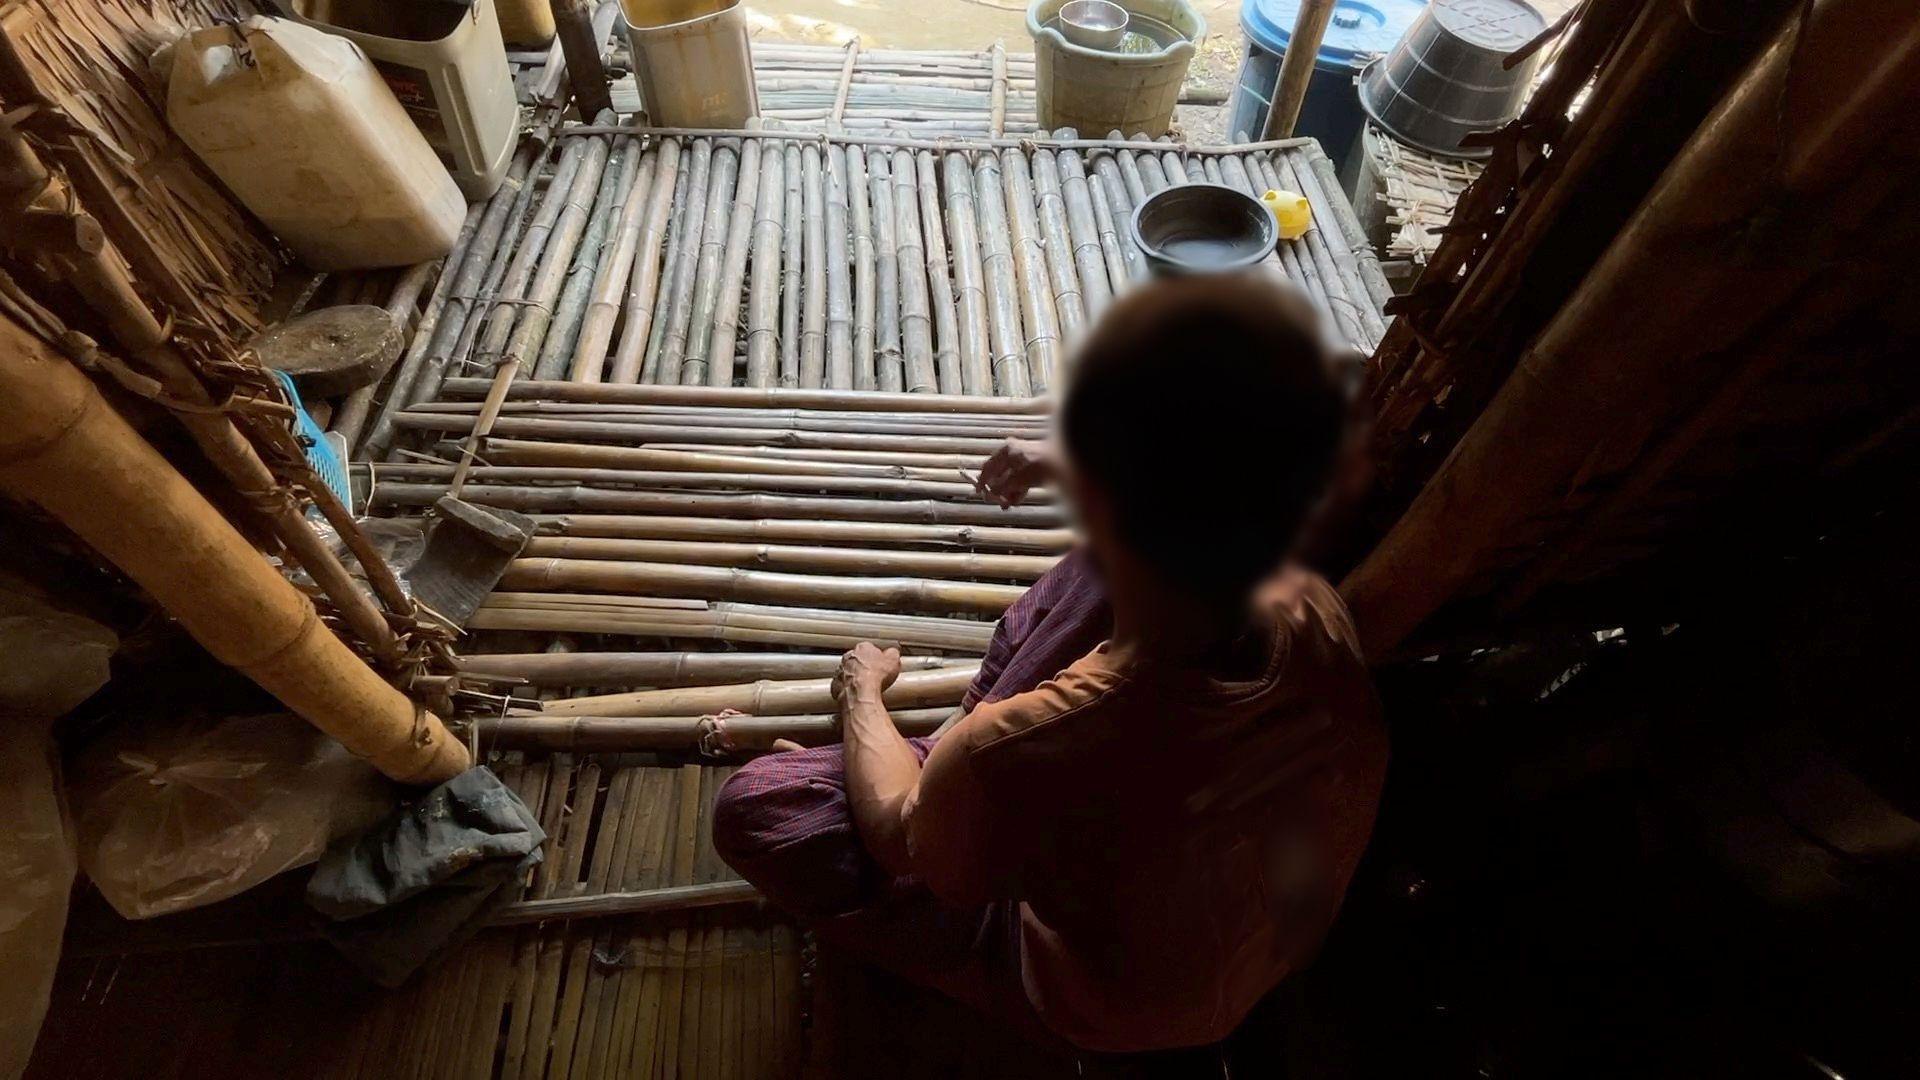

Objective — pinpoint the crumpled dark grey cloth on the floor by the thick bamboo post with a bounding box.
[307,767,547,986]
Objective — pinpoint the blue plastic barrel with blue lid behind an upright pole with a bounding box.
[1227,0,1427,161]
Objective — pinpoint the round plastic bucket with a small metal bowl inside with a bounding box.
[1027,0,1206,138]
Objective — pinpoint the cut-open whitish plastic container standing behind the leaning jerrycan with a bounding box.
[278,0,520,202]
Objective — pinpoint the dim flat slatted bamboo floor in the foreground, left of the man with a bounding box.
[29,755,803,1080]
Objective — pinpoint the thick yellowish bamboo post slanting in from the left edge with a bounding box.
[0,317,470,784]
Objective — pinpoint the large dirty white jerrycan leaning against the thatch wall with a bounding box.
[167,15,467,269]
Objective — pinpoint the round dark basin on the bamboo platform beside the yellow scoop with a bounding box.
[1133,184,1281,275]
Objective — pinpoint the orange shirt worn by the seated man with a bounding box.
[904,571,1386,1051]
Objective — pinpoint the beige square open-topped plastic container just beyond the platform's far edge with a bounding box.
[620,0,760,127]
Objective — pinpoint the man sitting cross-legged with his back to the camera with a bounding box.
[714,277,1386,1051]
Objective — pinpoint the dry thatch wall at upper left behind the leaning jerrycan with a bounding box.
[0,0,280,344]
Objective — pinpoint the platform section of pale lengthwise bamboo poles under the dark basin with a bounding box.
[361,125,1388,457]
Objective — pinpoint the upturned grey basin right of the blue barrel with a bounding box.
[1359,0,1548,158]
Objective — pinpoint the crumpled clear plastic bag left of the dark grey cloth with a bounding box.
[69,713,399,919]
